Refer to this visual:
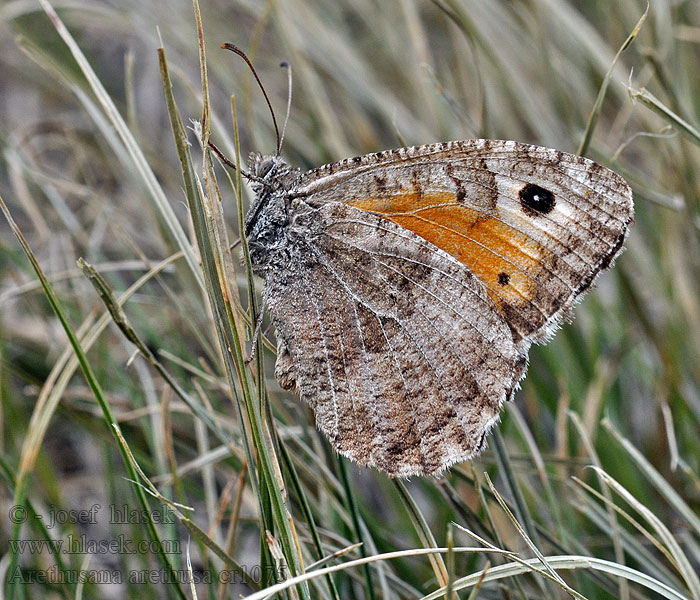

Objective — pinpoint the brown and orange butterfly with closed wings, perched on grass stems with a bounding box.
[245,139,634,477]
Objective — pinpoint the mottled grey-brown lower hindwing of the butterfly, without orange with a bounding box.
[267,203,526,476]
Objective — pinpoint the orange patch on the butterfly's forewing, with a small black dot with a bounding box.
[348,192,543,306]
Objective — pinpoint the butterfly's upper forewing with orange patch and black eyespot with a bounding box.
[302,140,633,341]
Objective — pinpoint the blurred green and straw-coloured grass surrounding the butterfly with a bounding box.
[0,0,700,599]
